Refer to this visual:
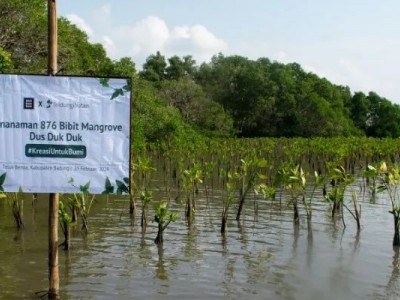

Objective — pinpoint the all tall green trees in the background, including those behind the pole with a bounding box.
[0,0,400,150]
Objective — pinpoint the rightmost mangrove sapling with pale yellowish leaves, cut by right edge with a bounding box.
[378,162,400,247]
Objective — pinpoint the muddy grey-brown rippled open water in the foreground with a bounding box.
[0,186,400,300]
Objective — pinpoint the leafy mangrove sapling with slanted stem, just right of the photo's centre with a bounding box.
[235,157,267,221]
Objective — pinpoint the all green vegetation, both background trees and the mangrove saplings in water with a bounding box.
[0,0,400,256]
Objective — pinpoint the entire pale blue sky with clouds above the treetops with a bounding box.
[57,0,400,104]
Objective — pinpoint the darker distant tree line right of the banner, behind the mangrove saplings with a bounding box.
[139,52,400,137]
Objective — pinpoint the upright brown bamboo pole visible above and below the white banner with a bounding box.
[47,0,60,299]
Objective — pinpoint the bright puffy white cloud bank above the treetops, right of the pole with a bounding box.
[63,9,228,68]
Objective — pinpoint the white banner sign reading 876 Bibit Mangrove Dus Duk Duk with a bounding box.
[0,75,130,194]
